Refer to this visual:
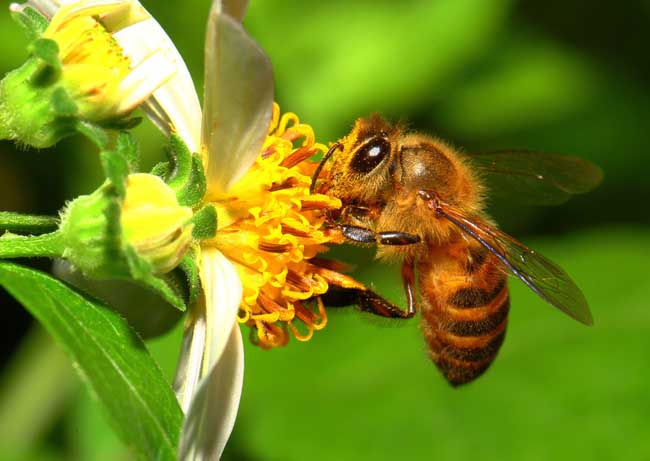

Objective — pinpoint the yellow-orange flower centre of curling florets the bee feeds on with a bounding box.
[206,105,353,349]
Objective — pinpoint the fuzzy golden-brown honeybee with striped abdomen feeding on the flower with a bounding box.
[312,115,602,386]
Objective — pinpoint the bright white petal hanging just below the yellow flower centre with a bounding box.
[174,248,242,413]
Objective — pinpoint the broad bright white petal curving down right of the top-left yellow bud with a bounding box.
[114,19,201,152]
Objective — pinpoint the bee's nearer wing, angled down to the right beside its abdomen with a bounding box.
[436,205,593,325]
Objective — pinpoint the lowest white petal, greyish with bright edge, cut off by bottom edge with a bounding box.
[178,325,244,461]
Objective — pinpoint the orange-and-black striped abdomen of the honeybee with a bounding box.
[418,242,510,386]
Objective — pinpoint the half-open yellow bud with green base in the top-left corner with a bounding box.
[0,2,176,148]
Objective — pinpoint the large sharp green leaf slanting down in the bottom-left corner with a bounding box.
[0,263,182,461]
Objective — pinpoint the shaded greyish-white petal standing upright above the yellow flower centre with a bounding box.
[201,5,273,194]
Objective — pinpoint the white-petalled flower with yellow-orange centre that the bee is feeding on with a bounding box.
[162,1,361,460]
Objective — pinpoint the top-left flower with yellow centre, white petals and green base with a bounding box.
[0,0,199,148]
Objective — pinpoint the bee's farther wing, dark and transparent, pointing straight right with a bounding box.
[468,151,603,205]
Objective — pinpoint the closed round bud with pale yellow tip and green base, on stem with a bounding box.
[61,174,193,279]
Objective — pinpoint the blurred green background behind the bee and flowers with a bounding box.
[0,0,650,461]
